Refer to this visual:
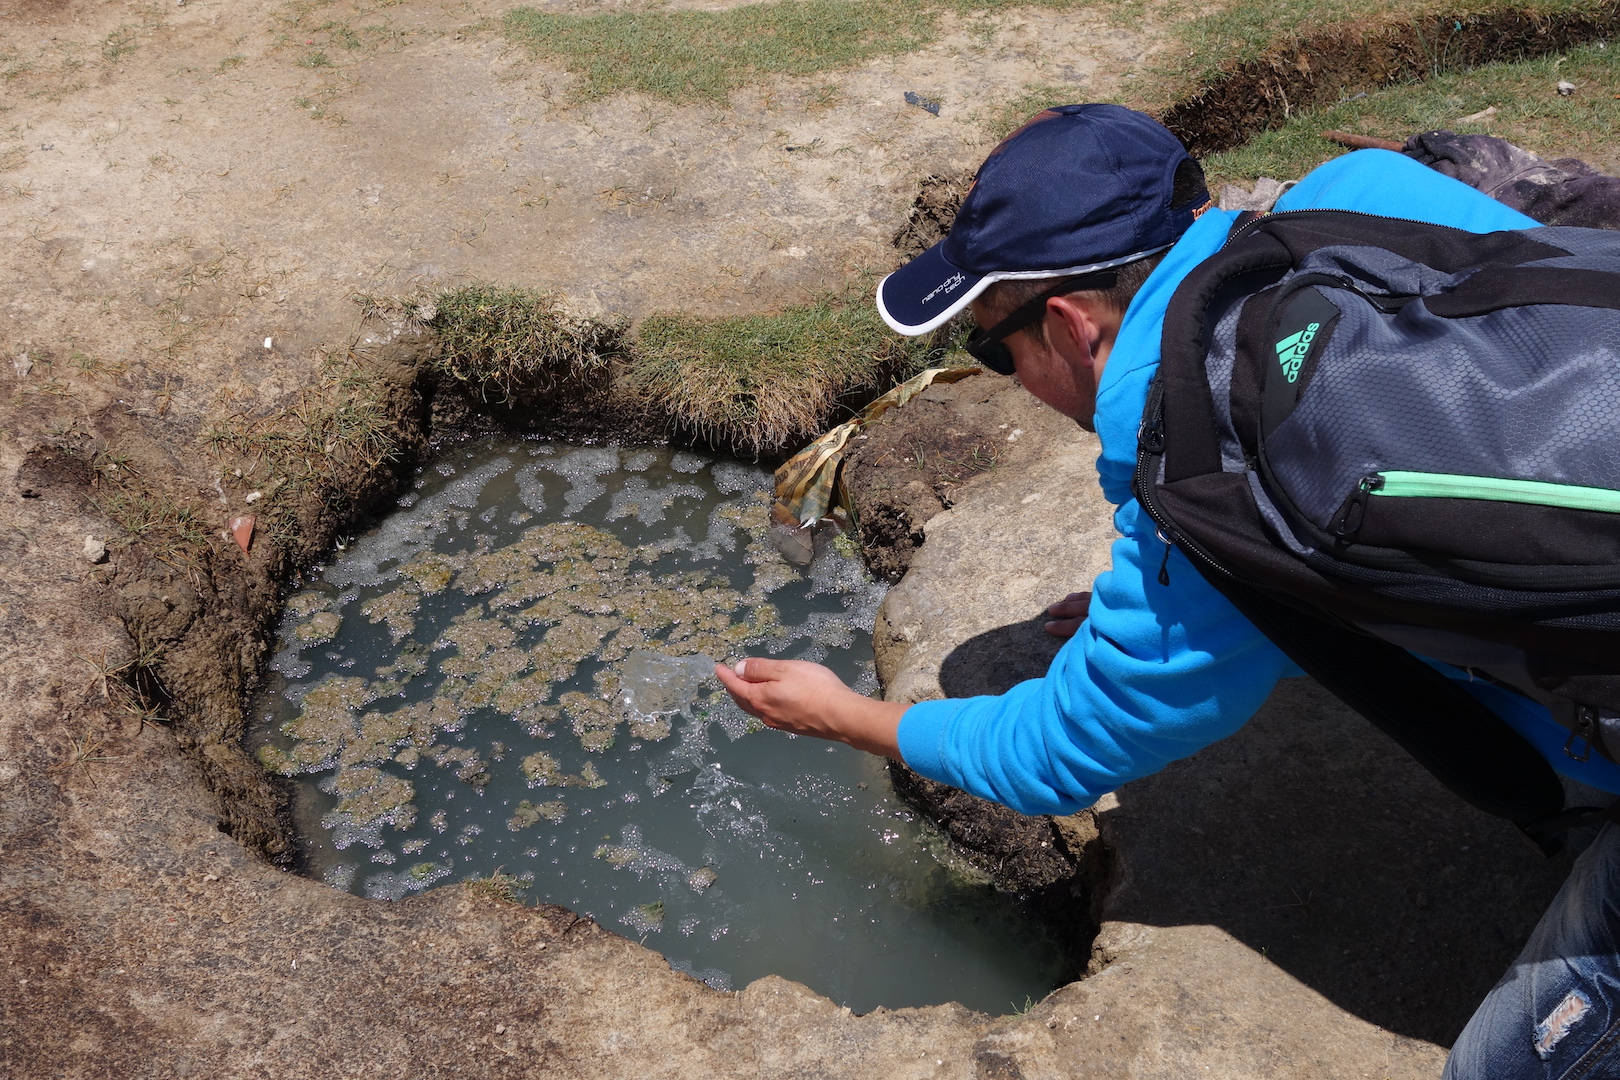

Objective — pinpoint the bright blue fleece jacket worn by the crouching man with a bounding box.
[899,151,1620,814]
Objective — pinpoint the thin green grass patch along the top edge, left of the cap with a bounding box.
[504,0,1089,104]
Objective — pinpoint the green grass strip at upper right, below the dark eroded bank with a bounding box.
[1204,45,1620,185]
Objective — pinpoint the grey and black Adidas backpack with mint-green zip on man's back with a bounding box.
[1134,210,1620,853]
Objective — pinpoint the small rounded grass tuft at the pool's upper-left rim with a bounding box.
[418,283,625,400]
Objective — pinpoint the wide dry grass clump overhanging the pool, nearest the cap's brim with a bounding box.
[625,290,936,453]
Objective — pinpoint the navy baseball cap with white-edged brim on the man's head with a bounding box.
[878,105,1209,335]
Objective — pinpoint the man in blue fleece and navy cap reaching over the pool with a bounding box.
[716,105,1620,1077]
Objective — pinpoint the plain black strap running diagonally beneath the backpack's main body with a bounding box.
[1192,560,1568,855]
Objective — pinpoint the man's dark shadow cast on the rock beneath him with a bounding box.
[940,617,1570,1046]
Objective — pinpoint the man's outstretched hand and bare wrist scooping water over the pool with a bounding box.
[714,656,909,759]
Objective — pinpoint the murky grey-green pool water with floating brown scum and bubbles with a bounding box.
[256,440,1066,1014]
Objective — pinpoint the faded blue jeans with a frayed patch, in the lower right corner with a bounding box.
[1445,824,1620,1080]
